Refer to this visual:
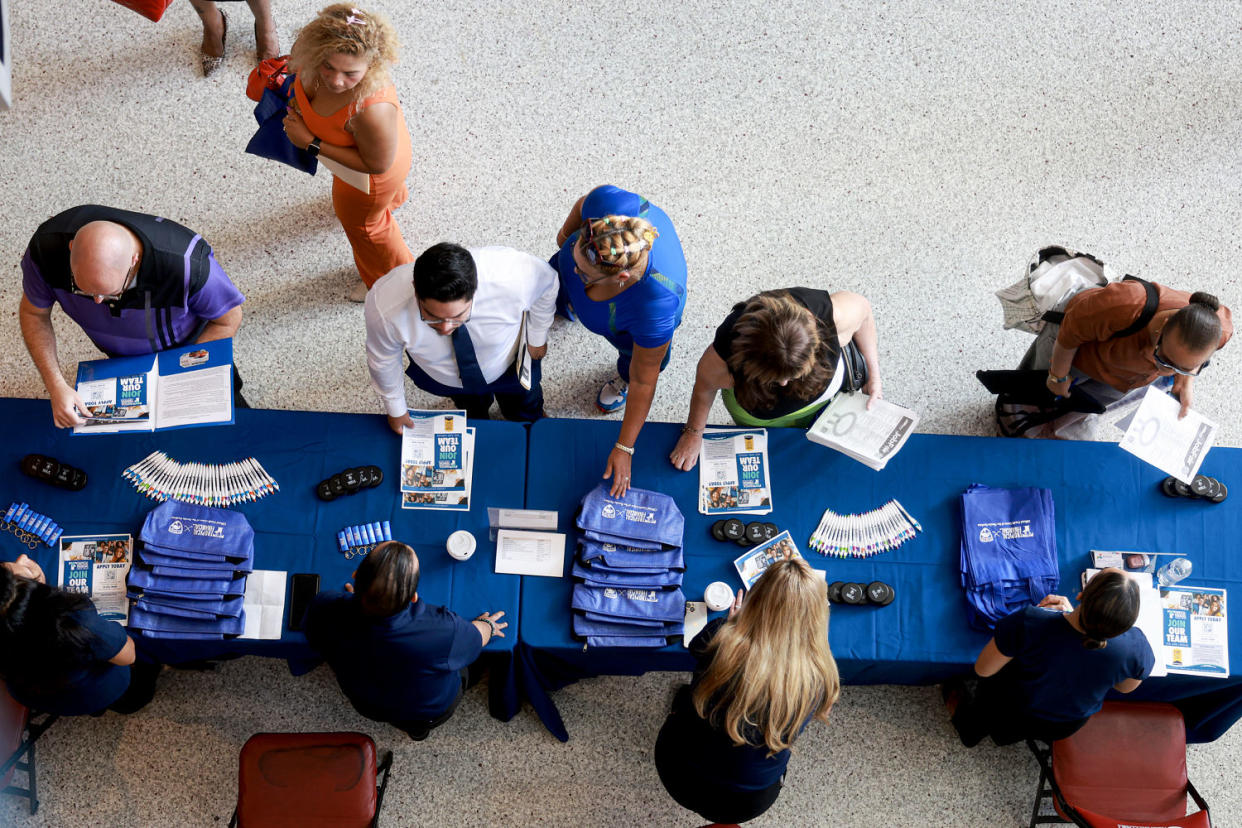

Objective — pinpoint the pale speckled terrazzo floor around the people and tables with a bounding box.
[0,0,1242,828]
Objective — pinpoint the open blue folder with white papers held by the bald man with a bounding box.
[73,339,233,434]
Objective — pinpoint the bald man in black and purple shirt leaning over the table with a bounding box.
[17,205,245,428]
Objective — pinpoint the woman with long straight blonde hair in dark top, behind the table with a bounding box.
[656,559,841,823]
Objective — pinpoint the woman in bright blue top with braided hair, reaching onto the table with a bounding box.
[550,185,686,497]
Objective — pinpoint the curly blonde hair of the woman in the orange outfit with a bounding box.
[289,2,401,102]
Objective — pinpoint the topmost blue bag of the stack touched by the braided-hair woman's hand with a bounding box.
[578,483,686,549]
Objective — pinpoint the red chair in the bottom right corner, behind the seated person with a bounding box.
[1026,701,1212,828]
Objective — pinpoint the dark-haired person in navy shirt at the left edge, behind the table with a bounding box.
[0,555,161,716]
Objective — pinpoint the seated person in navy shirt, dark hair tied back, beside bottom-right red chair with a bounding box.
[945,567,1155,747]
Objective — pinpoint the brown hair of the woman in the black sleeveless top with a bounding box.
[729,290,841,411]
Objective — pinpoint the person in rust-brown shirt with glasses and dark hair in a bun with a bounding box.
[1023,281,1233,416]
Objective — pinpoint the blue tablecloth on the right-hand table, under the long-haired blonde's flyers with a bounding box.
[519,420,1242,741]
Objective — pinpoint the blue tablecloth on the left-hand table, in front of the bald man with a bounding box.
[0,400,527,719]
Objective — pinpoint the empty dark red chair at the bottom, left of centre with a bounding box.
[229,732,392,828]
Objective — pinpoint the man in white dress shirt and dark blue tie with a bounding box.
[366,242,558,433]
